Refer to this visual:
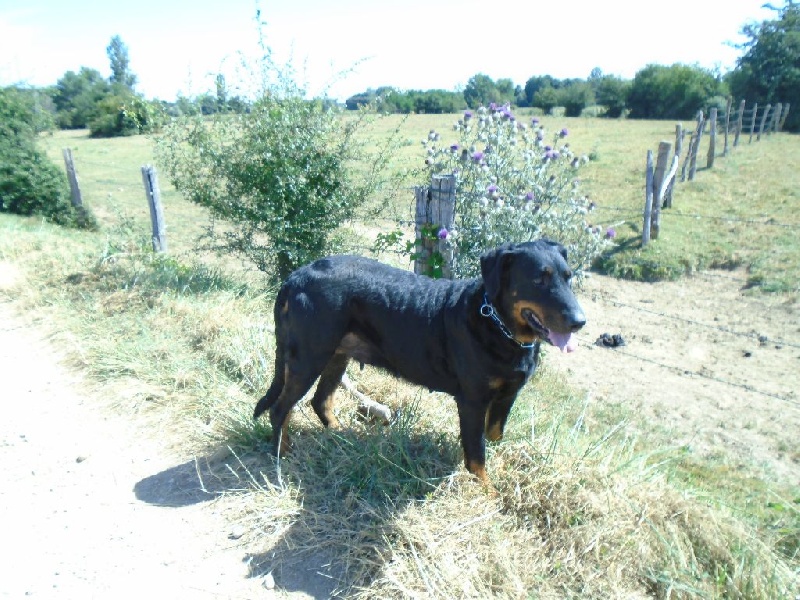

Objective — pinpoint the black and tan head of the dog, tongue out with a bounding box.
[481,239,586,352]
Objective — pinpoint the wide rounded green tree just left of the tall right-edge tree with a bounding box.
[628,64,727,119]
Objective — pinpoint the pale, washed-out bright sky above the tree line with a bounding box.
[0,0,780,100]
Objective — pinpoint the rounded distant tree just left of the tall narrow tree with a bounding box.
[53,67,111,129]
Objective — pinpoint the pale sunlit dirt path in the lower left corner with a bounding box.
[0,273,269,600]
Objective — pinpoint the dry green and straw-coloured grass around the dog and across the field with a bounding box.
[0,116,800,600]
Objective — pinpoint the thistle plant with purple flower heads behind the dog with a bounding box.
[423,105,610,277]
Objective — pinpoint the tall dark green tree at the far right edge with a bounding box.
[727,0,800,131]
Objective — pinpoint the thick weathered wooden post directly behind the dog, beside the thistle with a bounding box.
[414,175,456,279]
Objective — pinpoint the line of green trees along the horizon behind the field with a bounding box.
[3,0,800,136]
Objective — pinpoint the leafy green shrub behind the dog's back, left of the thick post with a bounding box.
[157,82,396,281]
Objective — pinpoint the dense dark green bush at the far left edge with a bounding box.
[0,87,96,228]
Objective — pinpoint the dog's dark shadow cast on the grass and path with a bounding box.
[134,427,461,598]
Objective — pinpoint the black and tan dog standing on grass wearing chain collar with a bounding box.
[254,240,586,482]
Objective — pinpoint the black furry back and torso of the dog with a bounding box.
[275,256,479,394]
